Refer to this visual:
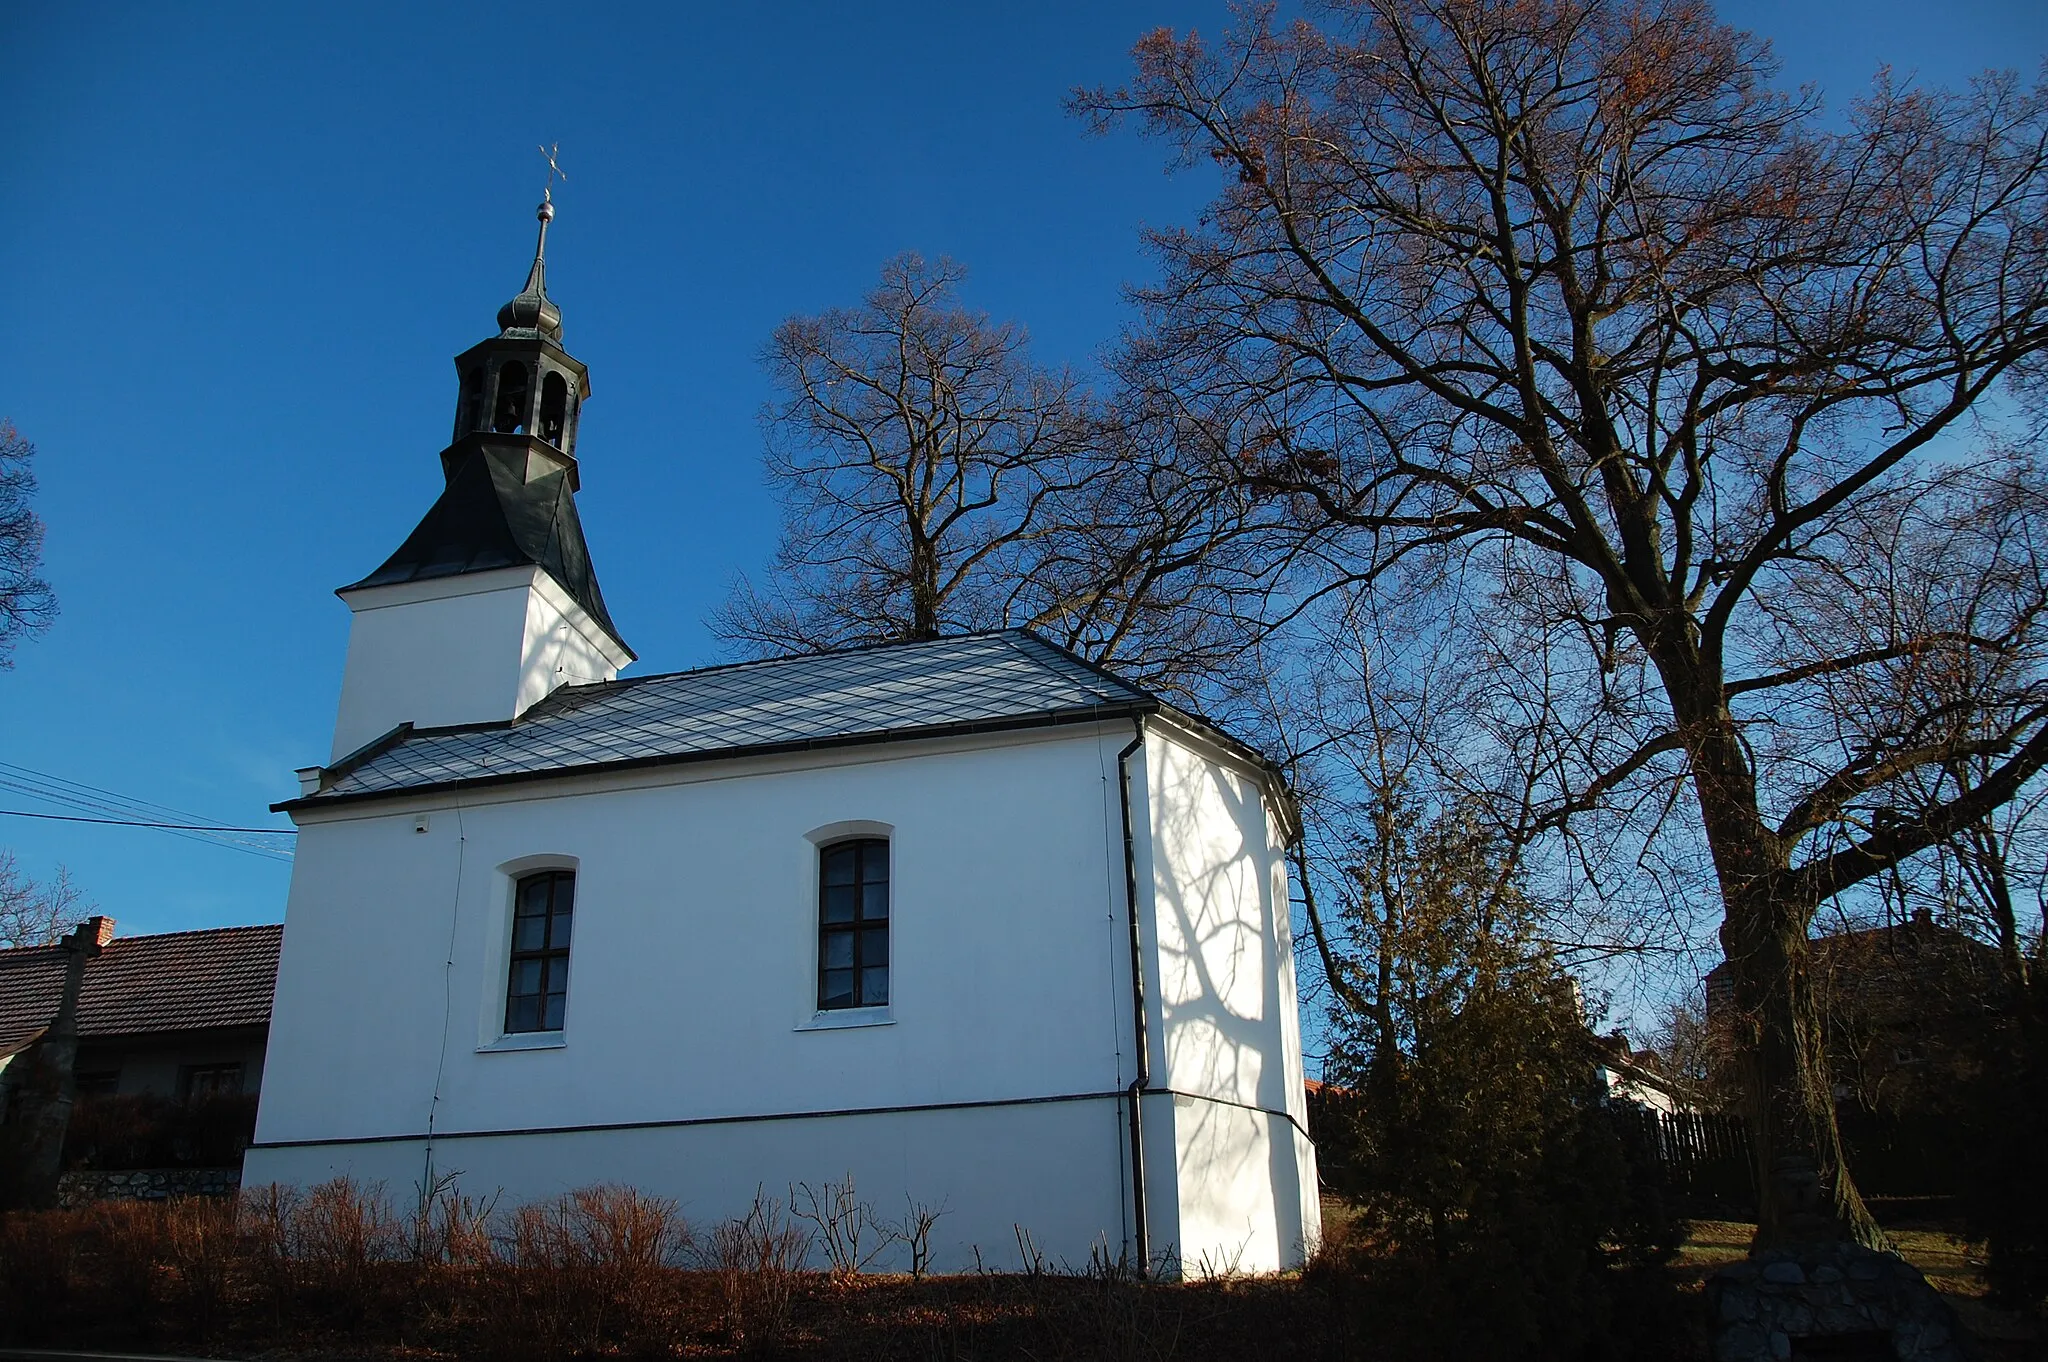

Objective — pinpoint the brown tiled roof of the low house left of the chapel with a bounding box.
[0,924,285,1055]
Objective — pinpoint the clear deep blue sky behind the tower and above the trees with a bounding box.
[0,0,2048,932]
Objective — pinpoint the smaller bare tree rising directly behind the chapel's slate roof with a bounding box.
[717,256,1092,651]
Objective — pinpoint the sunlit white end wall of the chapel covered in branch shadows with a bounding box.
[1145,725,1321,1274]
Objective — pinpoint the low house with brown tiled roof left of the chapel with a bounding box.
[0,918,283,1100]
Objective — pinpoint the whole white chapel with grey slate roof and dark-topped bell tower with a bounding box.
[244,193,1319,1272]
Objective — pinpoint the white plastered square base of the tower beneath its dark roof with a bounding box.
[328,567,629,762]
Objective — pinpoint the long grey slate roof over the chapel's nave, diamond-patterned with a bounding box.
[296,629,1179,809]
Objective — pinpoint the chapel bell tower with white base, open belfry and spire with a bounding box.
[330,193,635,764]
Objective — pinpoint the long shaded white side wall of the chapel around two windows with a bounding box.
[246,725,1133,1264]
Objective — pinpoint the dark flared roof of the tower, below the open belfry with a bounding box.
[342,434,633,653]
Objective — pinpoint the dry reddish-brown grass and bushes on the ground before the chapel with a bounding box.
[0,1184,2042,1362]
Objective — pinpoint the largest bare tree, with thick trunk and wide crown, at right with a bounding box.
[1075,0,2048,1239]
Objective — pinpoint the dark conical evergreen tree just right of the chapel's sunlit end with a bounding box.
[1317,791,1681,1358]
